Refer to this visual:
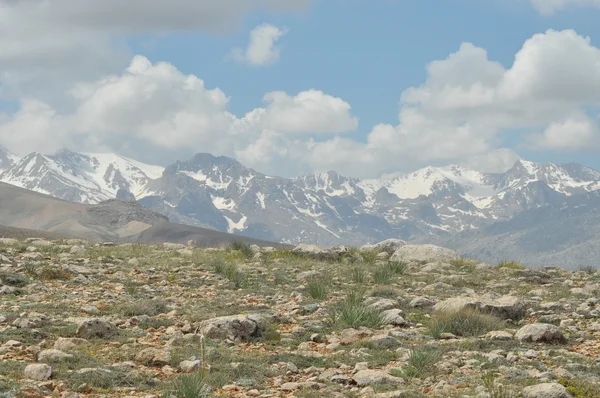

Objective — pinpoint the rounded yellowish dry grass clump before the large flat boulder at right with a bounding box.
[429,309,505,339]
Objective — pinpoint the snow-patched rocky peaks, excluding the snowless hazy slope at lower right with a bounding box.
[0,150,600,250]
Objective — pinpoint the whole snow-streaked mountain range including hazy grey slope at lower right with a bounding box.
[0,148,600,267]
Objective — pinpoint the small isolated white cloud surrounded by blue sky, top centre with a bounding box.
[231,24,287,66]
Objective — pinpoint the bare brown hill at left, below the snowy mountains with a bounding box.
[0,183,286,247]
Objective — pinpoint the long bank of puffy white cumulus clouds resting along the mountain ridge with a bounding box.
[0,30,600,177]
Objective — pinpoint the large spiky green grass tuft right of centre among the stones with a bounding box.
[329,293,383,328]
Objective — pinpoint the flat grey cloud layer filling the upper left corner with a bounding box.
[0,0,310,97]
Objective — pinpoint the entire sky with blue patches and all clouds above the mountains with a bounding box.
[0,0,600,178]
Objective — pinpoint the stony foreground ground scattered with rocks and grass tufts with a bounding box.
[0,238,600,398]
